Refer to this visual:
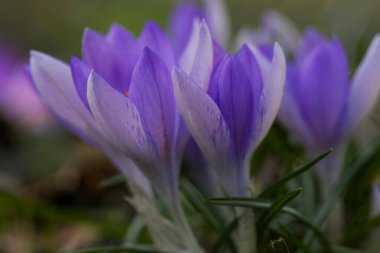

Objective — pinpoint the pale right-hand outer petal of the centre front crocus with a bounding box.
[254,43,286,148]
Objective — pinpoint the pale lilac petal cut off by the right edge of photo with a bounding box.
[347,35,380,131]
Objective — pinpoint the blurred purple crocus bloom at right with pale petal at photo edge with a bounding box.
[279,30,380,187]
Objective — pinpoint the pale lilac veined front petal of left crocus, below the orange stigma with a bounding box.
[87,72,154,167]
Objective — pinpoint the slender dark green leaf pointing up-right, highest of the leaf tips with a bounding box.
[258,149,332,198]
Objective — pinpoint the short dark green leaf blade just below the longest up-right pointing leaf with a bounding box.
[257,188,302,231]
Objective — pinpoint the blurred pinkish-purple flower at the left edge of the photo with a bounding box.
[0,46,51,130]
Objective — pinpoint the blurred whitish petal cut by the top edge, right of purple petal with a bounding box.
[205,0,231,47]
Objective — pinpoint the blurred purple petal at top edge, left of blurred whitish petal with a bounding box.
[169,2,204,56]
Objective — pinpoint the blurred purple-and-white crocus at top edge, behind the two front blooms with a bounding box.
[169,0,230,55]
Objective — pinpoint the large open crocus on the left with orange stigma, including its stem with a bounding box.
[30,22,213,252]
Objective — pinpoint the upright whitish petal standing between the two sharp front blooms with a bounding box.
[180,20,214,90]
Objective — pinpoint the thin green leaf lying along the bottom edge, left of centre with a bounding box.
[61,245,163,253]
